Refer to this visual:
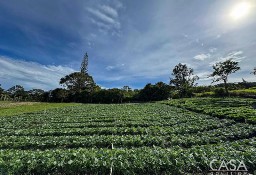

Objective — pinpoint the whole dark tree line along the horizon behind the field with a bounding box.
[0,53,256,103]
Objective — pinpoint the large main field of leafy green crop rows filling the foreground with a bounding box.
[0,103,256,175]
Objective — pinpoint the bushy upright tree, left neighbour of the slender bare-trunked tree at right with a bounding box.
[170,63,199,97]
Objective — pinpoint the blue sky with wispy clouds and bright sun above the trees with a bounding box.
[0,0,256,90]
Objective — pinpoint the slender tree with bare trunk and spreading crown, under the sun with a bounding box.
[209,59,240,94]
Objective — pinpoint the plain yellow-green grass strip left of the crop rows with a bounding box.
[0,101,79,116]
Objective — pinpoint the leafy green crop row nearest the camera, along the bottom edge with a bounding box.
[0,140,256,174]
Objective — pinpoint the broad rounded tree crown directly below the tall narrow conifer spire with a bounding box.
[60,72,95,93]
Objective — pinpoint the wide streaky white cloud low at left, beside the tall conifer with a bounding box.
[0,56,75,90]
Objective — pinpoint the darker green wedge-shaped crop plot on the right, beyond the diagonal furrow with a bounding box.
[162,98,256,123]
